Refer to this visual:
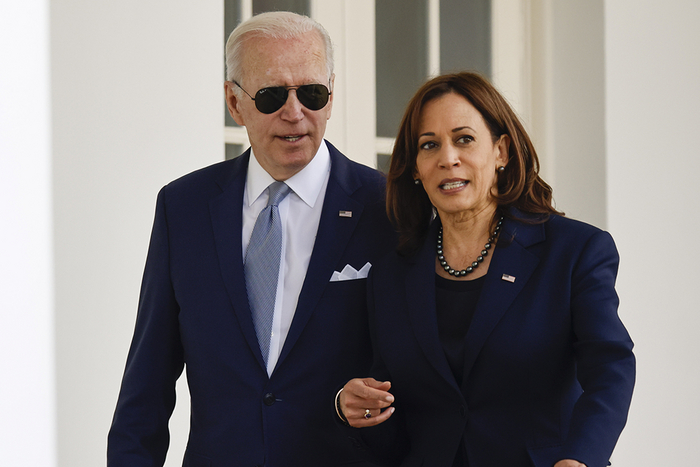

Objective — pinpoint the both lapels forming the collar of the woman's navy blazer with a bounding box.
[405,210,545,391]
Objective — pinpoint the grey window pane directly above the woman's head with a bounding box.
[440,0,491,78]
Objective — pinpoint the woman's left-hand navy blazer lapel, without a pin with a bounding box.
[405,221,459,391]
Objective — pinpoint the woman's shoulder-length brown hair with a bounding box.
[386,72,562,254]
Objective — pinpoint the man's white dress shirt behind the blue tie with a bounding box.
[242,141,331,375]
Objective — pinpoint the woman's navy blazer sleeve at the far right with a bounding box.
[563,231,635,467]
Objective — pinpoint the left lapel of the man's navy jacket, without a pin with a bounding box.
[209,150,266,369]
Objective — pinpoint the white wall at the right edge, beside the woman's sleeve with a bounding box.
[605,0,700,467]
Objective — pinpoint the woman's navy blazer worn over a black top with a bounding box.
[362,213,635,467]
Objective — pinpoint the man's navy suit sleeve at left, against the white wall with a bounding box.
[107,189,184,467]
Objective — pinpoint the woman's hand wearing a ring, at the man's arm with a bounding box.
[340,378,394,428]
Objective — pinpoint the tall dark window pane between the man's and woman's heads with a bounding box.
[375,0,428,138]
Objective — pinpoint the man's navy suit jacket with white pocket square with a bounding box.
[107,144,395,467]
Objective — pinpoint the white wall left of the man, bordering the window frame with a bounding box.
[50,0,224,467]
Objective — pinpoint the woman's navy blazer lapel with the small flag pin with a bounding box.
[464,219,545,381]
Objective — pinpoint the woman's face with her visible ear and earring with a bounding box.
[415,93,509,220]
